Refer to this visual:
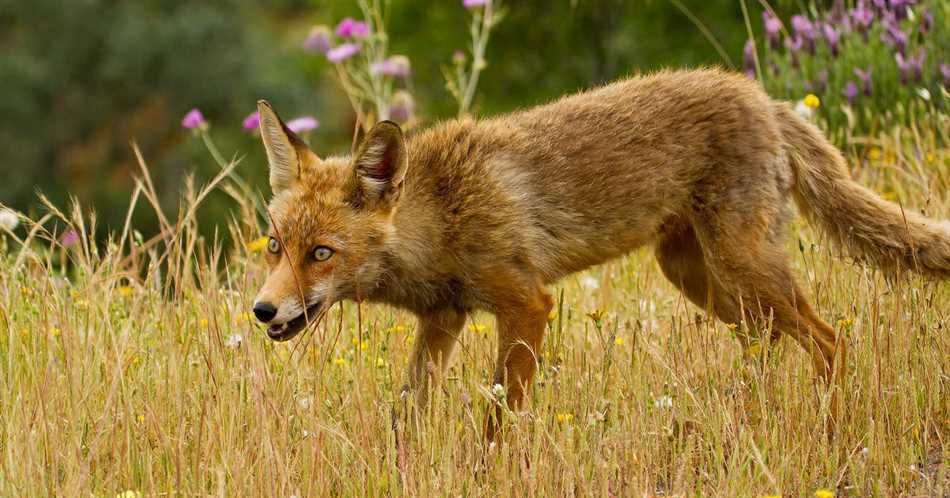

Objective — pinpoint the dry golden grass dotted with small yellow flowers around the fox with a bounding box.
[0,121,950,497]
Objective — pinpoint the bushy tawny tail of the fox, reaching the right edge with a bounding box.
[777,104,950,278]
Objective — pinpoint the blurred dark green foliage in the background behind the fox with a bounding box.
[0,0,820,241]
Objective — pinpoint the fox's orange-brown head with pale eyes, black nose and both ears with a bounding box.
[253,101,407,341]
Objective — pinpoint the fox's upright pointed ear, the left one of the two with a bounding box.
[257,100,306,194]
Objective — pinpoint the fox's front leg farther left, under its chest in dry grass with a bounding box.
[407,308,465,407]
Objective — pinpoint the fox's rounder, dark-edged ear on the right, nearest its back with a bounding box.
[353,121,408,204]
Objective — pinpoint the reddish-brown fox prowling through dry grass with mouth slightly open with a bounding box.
[252,68,950,437]
